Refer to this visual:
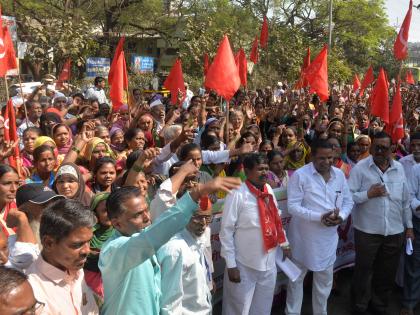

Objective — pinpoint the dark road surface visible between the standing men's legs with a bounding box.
[217,269,420,315]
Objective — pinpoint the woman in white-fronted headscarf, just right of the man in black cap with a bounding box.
[53,163,93,206]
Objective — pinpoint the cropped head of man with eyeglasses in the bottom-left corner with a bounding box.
[0,266,44,315]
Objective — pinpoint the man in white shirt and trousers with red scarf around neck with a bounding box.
[219,153,290,315]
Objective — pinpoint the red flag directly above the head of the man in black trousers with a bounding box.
[370,68,389,124]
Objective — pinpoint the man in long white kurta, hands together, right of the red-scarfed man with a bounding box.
[285,140,353,315]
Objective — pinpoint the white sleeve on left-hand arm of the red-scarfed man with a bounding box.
[219,190,241,268]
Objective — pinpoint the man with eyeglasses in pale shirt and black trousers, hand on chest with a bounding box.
[349,132,414,314]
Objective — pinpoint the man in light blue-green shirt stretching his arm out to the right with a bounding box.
[99,178,240,315]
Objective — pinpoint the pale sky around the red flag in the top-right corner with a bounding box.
[385,0,420,42]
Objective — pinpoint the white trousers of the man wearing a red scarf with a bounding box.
[222,262,277,315]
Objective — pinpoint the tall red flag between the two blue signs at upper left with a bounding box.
[108,51,128,111]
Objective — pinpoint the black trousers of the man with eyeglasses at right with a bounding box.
[352,229,404,312]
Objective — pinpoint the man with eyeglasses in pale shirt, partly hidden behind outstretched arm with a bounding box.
[157,197,212,315]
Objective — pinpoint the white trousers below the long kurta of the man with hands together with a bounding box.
[285,262,334,315]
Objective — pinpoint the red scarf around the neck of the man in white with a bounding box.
[245,180,287,252]
